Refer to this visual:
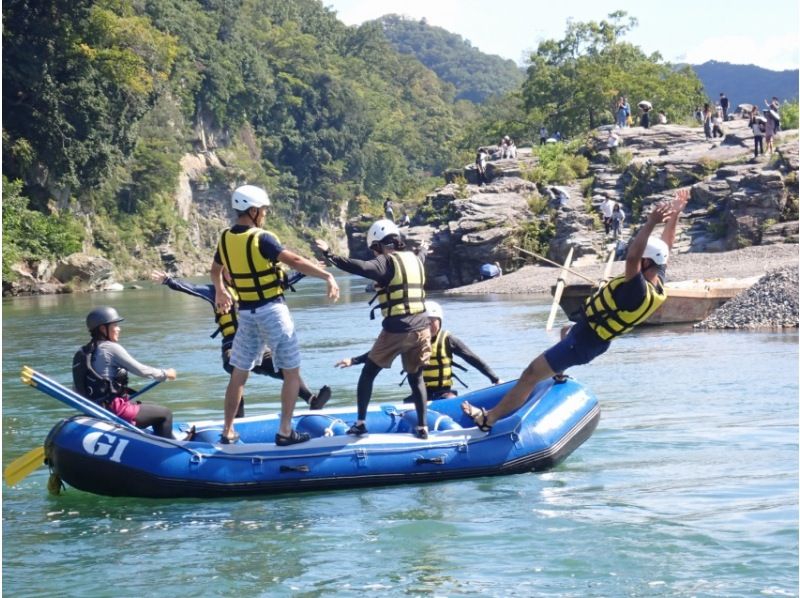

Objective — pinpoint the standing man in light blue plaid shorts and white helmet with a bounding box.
[211,185,339,446]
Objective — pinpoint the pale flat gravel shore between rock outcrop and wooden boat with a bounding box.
[446,244,798,298]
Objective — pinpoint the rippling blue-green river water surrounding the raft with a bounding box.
[2,276,798,598]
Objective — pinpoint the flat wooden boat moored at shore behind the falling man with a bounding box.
[553,276,759,325]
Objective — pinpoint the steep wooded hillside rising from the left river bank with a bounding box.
[3,0,466,276]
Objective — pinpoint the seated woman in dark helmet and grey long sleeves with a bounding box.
[72,307,182,438]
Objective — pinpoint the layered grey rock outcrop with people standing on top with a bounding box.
[347,119,798,289]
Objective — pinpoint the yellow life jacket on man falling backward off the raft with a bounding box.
[584,276,667,341]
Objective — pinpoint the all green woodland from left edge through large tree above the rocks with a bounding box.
[2,0,720,289]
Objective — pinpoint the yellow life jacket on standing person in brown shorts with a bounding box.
[370,251,425,318]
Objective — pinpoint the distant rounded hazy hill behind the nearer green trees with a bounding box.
[377,15,525,103]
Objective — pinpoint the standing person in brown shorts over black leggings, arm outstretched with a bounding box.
[316,220,431,439]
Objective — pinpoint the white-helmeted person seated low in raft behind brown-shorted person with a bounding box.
[336,301,500,403]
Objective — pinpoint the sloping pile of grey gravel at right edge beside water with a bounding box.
[694,264,800,328]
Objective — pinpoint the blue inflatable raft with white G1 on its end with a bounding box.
[45,379,600,498]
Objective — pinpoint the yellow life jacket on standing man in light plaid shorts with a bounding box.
[217,228,283,302]
